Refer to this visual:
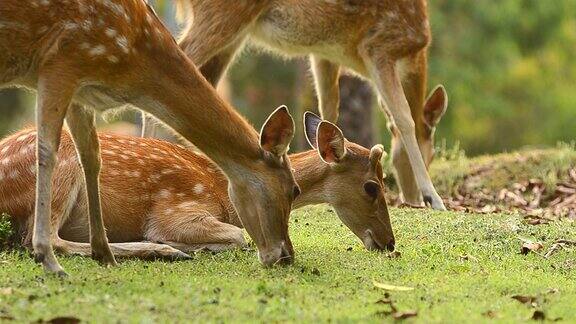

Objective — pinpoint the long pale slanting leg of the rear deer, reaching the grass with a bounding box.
[366,59,446,210]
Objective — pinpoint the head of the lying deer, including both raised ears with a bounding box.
[302,113,395,251]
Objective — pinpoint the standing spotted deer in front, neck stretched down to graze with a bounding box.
[0,0,298,273]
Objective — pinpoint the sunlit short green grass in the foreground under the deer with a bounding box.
[0,206,576,323]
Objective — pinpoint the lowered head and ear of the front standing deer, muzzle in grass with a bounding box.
[228,106,300,266]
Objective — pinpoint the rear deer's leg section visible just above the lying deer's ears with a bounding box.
[310,55,340,123]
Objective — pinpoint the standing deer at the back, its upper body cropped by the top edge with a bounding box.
[158,0,446,209]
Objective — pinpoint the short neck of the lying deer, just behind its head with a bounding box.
[290,150,330,208]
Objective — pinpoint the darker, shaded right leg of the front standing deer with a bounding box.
[66,104,116,265]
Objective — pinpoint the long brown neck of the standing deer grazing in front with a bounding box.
[131,51,262,178]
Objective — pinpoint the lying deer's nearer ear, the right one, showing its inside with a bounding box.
[316,120,346,163]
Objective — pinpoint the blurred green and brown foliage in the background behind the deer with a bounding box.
[0,0,576,155]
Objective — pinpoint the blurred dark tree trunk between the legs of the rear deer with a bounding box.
[338,75,375,148]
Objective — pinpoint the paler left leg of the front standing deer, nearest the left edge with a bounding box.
[32,74,75,275]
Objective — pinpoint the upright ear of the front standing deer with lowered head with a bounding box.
[260,106,294,157]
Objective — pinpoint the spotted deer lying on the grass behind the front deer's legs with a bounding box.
[0,113,394,259]
